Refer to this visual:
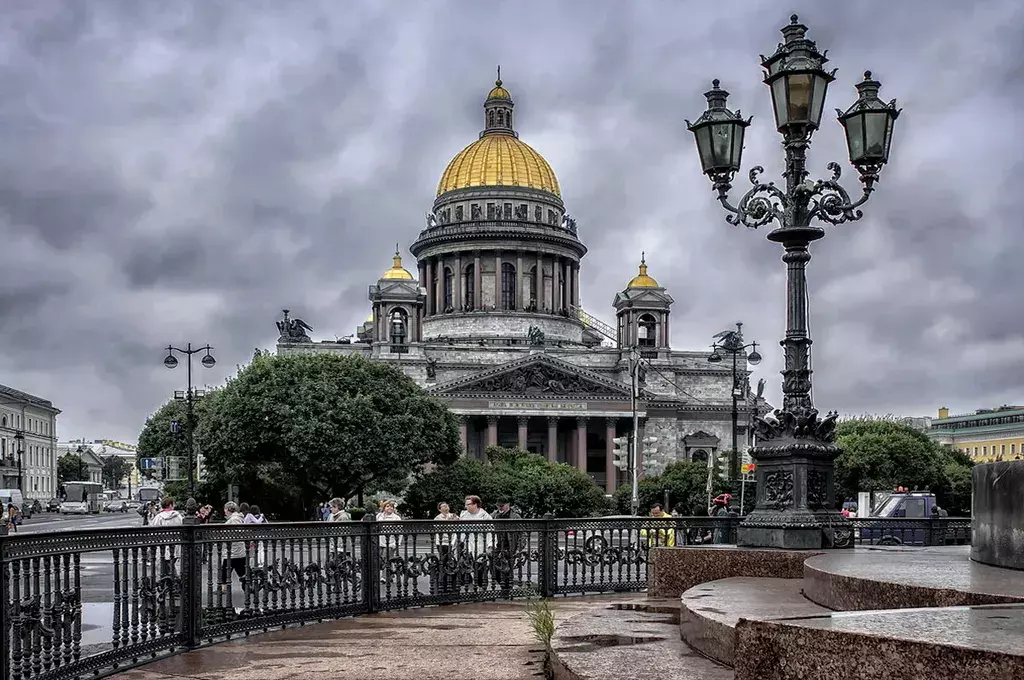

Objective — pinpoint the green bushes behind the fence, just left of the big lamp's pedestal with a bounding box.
[614,457,724,516]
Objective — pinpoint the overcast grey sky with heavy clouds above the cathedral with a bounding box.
[0,0,1024,440]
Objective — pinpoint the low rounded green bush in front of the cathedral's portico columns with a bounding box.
[402,447,608,519]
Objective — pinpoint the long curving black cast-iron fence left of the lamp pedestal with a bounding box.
[0,517,739,680]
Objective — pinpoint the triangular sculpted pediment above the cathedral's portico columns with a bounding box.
[429,354,630,399]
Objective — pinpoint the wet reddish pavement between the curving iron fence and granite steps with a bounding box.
[113,596,606,680]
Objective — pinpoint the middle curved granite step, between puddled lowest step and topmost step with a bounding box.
[679,577,829,667]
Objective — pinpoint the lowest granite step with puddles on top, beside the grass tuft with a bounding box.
[551,604,733,680]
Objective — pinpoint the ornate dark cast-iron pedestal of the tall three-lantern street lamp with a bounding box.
[736,410,854,550]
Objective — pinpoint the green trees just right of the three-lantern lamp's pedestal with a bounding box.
[836,417,973,515]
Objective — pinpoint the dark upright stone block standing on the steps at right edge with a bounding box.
[971,461,1024,569]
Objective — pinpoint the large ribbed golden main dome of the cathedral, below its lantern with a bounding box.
[437,134,561,198]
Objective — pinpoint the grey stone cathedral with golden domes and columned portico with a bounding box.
[278,74,767,493]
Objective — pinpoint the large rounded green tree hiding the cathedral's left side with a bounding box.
[191,354,460,518]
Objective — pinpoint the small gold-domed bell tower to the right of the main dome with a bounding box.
[612,253,675,352]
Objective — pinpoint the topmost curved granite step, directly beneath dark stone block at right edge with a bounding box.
[804,546,1024,611]
